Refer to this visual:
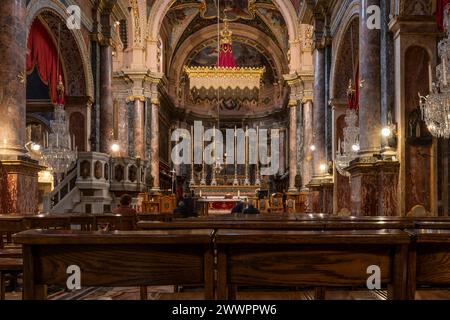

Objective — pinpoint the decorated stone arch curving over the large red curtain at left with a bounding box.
[26,0,94,99]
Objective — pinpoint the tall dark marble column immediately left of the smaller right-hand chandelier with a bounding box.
[313,48,326,178]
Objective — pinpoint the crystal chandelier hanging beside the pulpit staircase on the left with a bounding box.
[42,77,77,175]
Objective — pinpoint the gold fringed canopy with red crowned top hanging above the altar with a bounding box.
[184,20,266,101]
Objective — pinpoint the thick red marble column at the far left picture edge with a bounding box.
[0,0,27,157]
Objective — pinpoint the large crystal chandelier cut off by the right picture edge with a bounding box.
[419,6,450,139]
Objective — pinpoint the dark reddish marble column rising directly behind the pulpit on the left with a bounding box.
[100,43,114,153]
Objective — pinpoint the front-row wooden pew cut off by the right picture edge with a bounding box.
[407,229,450,300]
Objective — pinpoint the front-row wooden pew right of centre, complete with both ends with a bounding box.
[215,230,409,299]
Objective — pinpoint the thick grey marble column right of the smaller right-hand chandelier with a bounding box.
[359,0,381,158]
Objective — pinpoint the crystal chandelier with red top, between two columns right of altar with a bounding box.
[335,80,359,177]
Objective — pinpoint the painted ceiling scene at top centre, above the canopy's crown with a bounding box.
[200,0,255,21]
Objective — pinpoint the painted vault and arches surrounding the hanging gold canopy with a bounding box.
[158,0,289,114]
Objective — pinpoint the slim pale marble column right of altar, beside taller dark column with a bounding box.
[302,100,314,190]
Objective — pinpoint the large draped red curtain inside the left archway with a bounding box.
[27,19,64,104]
